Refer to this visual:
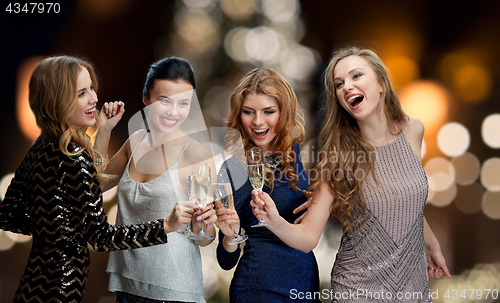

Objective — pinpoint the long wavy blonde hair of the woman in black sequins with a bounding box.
[29,56,109,182]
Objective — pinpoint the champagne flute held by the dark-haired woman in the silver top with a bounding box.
[191,164,214,240]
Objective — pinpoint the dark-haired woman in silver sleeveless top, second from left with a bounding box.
[96,57,217,303]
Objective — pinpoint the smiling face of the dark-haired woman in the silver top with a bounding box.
[143,80,194,134]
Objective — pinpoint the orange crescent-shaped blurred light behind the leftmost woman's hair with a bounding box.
[16,57,45,140]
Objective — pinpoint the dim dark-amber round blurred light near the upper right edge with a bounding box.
[452,64,492,102]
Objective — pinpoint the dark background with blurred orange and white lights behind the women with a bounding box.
[0,0,500,303]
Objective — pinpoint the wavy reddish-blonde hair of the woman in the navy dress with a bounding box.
[226,68,304,189]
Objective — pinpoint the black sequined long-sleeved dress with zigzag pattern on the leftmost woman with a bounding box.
[0,138,167,303]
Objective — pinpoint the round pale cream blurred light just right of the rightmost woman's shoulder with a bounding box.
[437,122,470,157]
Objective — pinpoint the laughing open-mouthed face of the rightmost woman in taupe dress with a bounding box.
[333,56,384,121]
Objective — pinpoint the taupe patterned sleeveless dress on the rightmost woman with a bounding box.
[331,132,431,303]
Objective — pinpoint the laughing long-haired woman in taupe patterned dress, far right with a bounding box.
[252,47,449,302]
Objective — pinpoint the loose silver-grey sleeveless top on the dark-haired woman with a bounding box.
[107,136,205,302]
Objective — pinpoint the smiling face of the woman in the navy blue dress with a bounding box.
[241,93,280,151]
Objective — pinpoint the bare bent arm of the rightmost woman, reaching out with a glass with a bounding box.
[251,184,334,253]
